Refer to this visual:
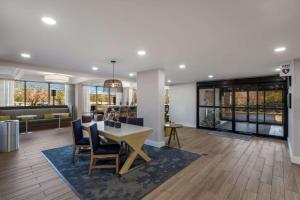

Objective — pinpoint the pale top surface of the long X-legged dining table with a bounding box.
[82,121,153,137]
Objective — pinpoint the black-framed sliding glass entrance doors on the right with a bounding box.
[197,76,287,138]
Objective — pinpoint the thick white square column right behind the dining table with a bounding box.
[137,69,165,147]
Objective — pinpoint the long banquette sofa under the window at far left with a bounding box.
[0,106,73,132]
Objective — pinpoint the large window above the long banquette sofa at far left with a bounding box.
[14,81,67,106]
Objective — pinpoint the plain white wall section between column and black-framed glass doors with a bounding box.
[169,83,196,127]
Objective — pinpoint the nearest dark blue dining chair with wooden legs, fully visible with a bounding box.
[89,123,121,175]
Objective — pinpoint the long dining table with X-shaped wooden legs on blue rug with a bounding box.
[82,121,153,175]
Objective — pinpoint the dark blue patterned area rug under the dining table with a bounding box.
[43,145,200,200]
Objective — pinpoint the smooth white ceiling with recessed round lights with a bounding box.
[0,0,300,83]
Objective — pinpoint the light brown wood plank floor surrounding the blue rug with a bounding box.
[0,128,300,200]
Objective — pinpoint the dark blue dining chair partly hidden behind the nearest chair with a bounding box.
[72,119,90,163]
